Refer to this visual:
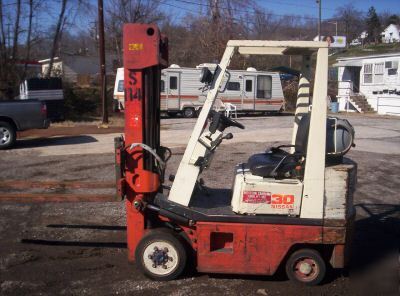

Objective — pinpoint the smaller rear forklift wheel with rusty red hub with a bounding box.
[286,249,326,286]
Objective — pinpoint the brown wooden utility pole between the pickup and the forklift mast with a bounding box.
[97,0,108,127]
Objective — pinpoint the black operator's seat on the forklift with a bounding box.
[247,114,310,177]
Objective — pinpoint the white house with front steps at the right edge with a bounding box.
[334,52,400,115]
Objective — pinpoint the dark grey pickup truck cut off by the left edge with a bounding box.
[0,100,50,149]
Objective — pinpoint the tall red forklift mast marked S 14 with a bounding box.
[116,24,168,260]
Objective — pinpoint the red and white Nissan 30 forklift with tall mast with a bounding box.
[115,24,357,285]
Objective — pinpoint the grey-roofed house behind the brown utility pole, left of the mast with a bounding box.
[39,54,119,86]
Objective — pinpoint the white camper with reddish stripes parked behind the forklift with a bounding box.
[114,64,284,118]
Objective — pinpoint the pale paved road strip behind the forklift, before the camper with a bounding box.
[10,115,400,156]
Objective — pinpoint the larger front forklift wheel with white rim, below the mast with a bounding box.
[135,229,187,281]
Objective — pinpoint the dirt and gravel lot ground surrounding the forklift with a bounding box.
[0,116,400,295]
